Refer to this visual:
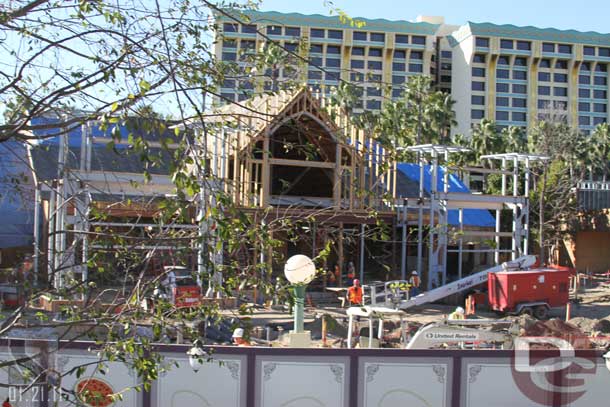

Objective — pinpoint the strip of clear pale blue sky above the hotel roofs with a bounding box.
[261,0,610,33]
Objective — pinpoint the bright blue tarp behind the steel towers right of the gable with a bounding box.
[397,163,496,227]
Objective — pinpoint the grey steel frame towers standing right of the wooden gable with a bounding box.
[397,144,549,290]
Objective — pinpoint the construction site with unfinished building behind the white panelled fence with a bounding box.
[2,89,610,405]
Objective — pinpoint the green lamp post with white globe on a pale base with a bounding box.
[284,254,316,348]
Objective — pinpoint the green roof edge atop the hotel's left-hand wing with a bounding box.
[215,10,438,35]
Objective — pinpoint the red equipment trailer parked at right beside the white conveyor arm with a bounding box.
[487,268,571,319]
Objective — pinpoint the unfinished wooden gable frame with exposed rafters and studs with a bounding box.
[208,88,395,214]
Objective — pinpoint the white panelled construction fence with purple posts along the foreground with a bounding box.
[0,341,610,407]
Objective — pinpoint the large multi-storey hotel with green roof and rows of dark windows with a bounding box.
[215,11,610,134]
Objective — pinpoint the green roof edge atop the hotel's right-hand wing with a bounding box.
[450,21,610,46]
